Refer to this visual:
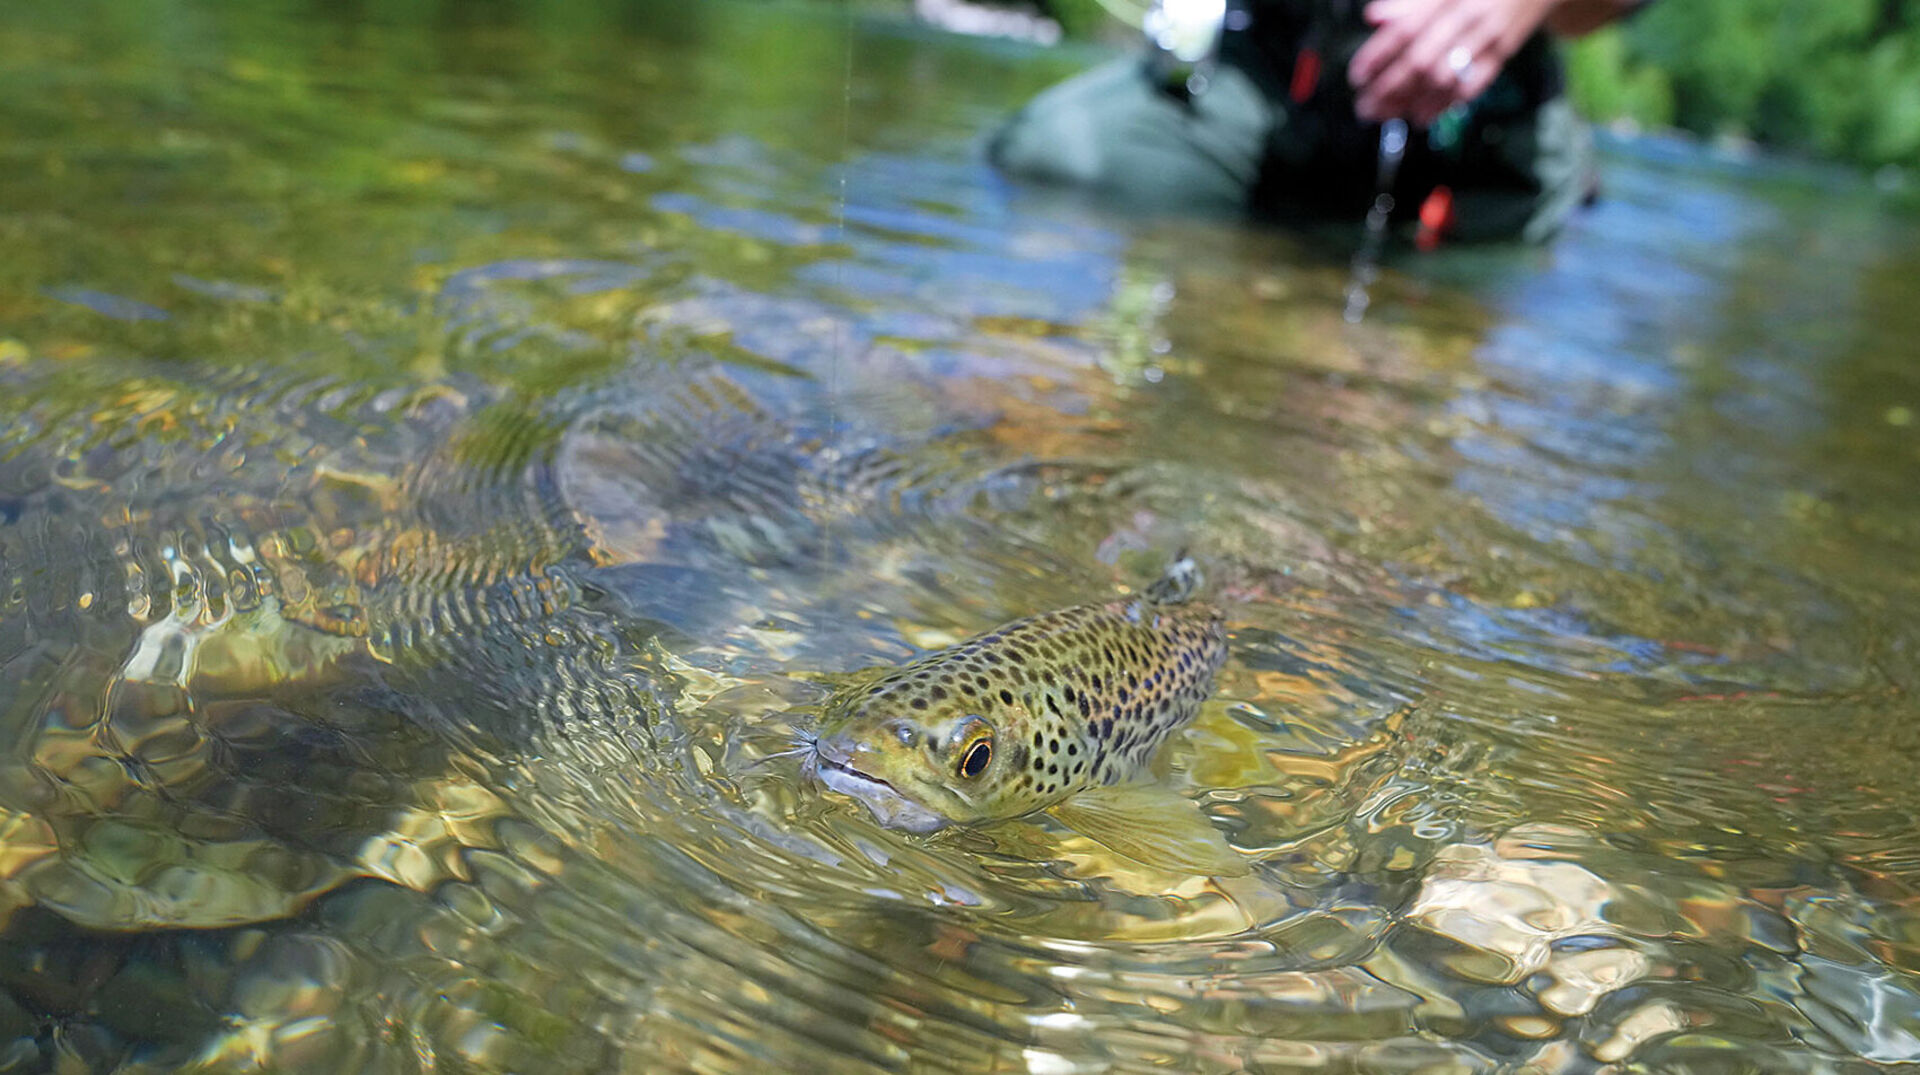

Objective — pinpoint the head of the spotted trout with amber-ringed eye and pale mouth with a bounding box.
[806,681,1044,833]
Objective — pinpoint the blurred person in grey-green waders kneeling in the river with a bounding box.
[989,0,1645,246]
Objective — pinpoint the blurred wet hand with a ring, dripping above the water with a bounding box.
[1346,0,1555,127]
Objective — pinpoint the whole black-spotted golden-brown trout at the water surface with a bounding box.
[804,559,1246,875]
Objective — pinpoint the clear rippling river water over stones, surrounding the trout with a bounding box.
[0,2,1920,1073]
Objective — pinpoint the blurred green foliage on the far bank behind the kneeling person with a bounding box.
[1043,0,1920,165]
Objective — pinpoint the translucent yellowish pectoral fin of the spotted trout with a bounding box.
[1048,783,1250,877]
